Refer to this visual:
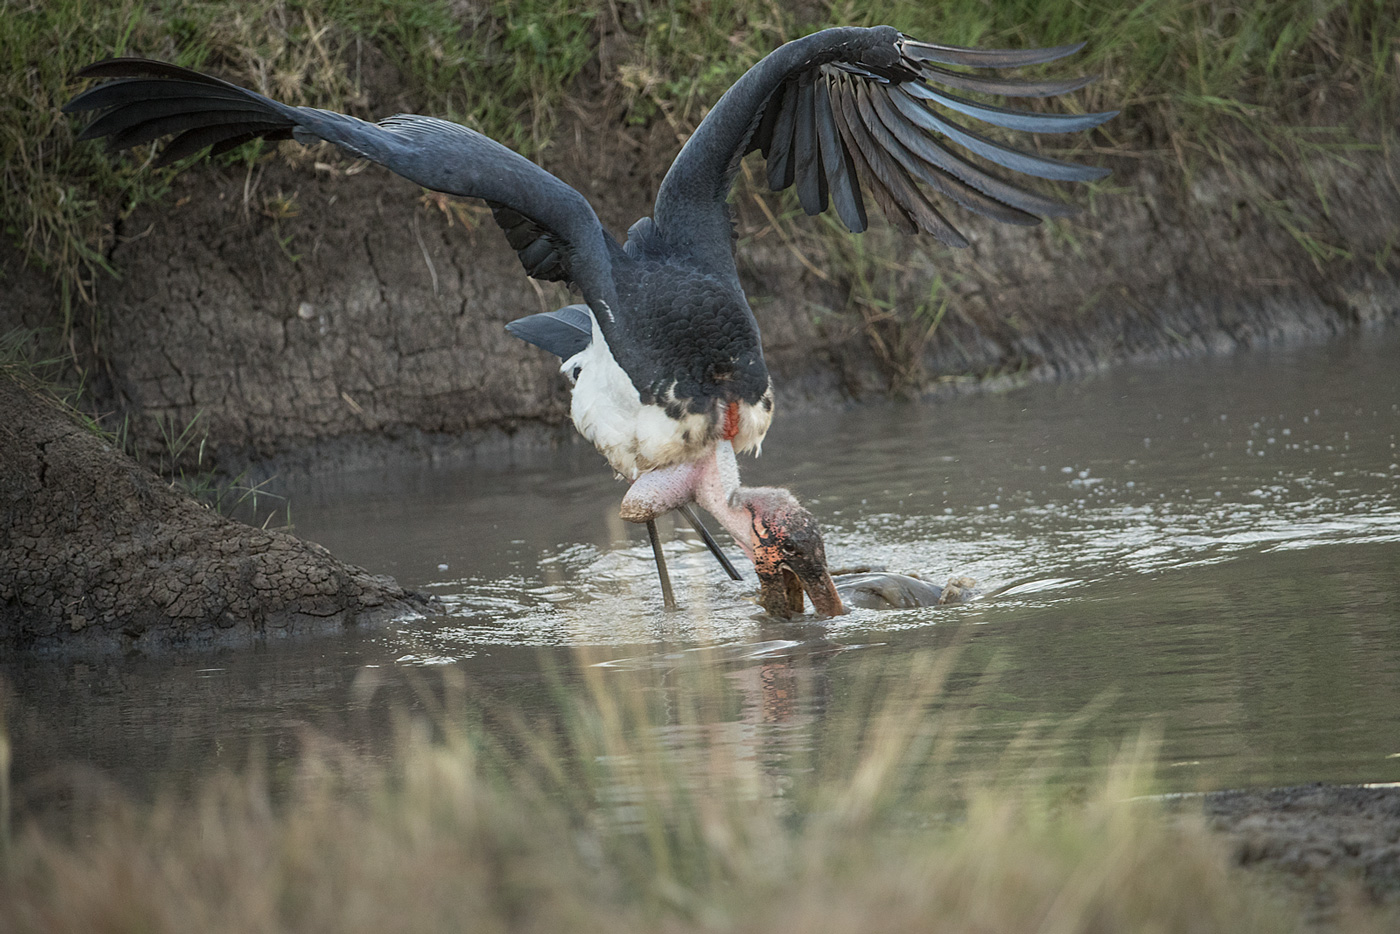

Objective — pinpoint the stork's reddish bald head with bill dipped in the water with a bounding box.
[735,487,846,618]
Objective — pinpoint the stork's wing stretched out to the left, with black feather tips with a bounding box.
[63,59,615,302]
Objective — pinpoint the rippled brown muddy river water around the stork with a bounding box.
[3,330,1400,800]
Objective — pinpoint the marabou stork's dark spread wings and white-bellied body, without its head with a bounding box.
[64,27,1113,605]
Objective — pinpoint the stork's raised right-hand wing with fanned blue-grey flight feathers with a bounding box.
[655,27,1114,270]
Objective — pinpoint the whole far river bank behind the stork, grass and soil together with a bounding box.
[0,0,1400,475]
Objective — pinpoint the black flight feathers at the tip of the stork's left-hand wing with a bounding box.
[63,59,297,165]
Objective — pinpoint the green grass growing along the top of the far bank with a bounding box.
[0,0,1400,394]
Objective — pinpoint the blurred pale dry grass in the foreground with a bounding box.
[0,653,1388,934]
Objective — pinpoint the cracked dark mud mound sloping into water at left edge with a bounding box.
[0,372,427,658]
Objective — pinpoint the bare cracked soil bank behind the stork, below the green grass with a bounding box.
[0,108,1400,468]
